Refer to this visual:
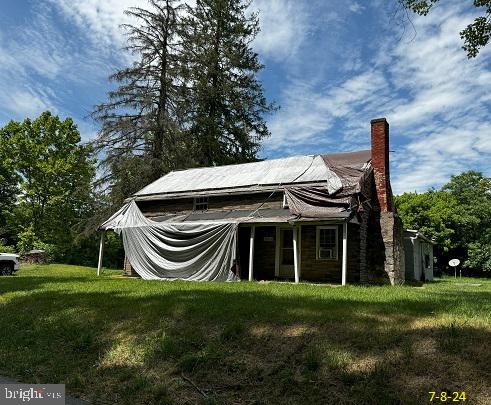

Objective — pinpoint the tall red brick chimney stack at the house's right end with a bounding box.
[370,118,393,212]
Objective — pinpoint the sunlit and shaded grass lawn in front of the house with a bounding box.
[0,265,491,404]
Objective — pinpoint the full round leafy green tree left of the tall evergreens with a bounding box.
[2,111,95,255]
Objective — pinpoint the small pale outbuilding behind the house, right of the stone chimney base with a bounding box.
[404,229,435,281]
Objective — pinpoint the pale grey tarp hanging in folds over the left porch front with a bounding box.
[101,201,237,281]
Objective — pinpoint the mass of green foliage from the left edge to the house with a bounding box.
[0,112,121,264]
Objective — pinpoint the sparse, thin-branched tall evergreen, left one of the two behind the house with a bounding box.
[92,0,188,191]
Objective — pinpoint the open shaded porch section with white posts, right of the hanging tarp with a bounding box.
[237,221,360,285]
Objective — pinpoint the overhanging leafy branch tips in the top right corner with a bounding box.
[398,0,491,59]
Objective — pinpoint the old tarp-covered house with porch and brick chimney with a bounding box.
[99,118,405,285]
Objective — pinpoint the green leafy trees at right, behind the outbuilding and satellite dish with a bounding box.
[395,170,491,274]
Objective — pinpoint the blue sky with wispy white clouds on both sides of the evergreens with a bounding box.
[0,0,491,194]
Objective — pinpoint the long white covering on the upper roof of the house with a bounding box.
[134,155,341,200]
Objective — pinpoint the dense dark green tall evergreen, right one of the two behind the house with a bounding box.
[182,0,275,166]
